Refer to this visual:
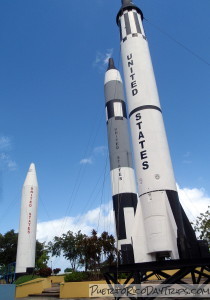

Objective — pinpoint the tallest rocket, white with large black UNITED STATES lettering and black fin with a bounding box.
[117,0,203,262]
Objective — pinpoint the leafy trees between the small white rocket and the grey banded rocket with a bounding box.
[48,229,117,272]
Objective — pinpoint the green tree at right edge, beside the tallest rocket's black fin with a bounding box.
[193,206,210,248]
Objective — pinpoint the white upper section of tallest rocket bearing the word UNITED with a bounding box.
[121,35,160,110]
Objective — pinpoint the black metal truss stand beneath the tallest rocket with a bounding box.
[101,258,210,300]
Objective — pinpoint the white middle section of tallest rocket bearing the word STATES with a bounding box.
[130,108,176,195]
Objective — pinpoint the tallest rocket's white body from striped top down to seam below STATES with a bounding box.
[120,10,176,195]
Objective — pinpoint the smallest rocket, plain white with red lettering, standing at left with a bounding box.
[15,163,38,273]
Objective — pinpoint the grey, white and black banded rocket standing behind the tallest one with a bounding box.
[104,58,148,263]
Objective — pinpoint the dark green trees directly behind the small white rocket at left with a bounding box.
[0,229,48,267]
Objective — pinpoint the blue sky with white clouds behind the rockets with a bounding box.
[0,0,210,270]
